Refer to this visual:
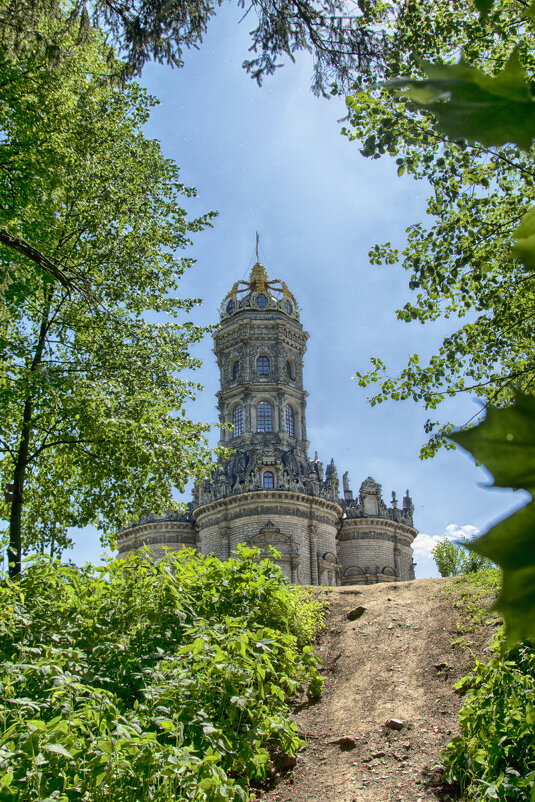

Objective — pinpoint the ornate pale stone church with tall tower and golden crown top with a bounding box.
[118,261,417,585]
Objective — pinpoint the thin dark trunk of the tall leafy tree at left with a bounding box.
[7,290,52,579]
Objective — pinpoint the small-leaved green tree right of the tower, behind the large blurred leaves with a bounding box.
[345,0,535,456]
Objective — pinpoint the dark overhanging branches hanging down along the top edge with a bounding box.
[0,0,386,94]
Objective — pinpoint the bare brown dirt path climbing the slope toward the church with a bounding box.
[261,579,498,802]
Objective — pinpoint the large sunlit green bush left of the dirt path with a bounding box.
[0,549,321,802]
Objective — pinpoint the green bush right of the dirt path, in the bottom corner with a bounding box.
[443,635,535,802]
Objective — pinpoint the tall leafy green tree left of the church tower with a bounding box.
[0,14,218,574]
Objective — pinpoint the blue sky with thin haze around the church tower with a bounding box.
[66,5,524,577]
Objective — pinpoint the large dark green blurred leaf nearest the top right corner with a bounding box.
[386,49,535,150]
